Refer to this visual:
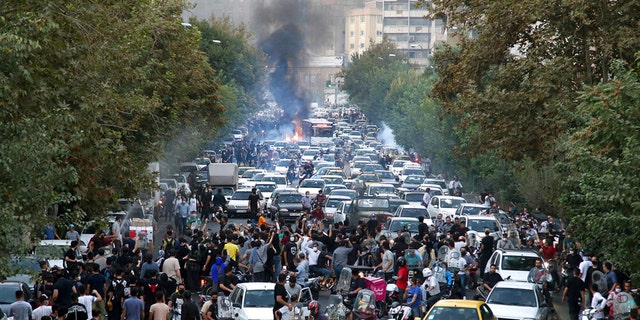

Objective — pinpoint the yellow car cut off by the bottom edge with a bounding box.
[424,299,497,320]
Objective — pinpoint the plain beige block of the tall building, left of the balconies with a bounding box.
[344,1,383,61]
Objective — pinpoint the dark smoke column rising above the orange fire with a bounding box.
[253,0,326,124]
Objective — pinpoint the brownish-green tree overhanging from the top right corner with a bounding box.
[421,0,640,163]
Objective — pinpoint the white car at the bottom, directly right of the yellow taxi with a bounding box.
[486,281,551,320]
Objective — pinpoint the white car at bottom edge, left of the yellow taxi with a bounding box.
[218,282,276,320]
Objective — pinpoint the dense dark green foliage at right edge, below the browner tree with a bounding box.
[557,61,640,276]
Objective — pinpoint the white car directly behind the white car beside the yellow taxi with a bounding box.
[484,249,546,282]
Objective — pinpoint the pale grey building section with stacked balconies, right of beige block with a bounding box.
[382,0,447,66]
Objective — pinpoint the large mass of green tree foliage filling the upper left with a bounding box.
[0,0,223,273]
